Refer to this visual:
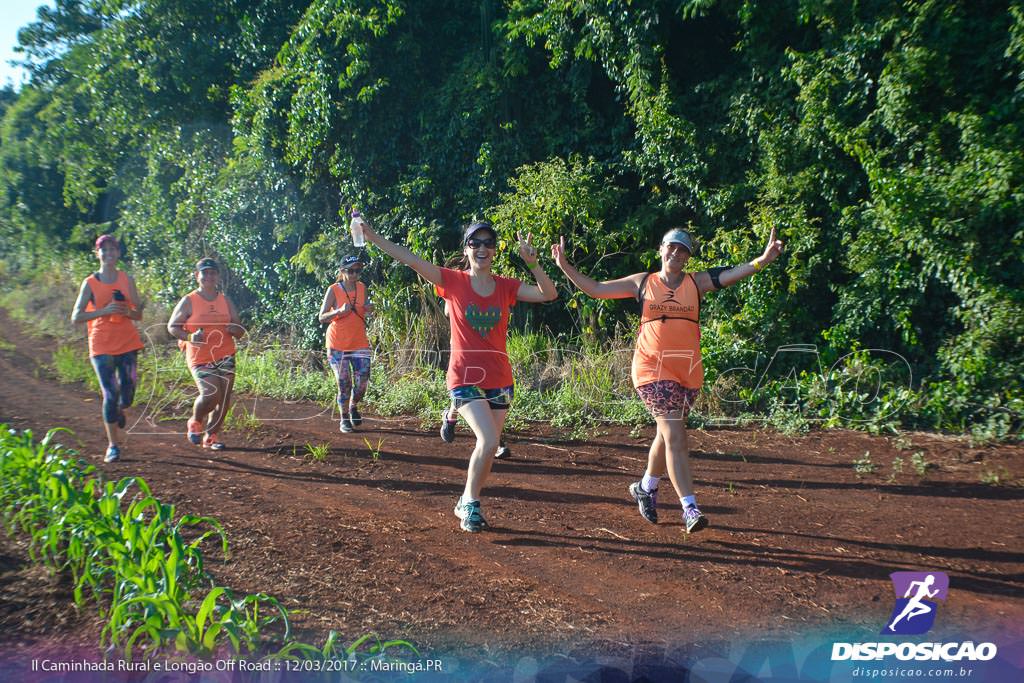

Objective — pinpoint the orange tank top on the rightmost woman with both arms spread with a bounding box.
[633,272,703,389]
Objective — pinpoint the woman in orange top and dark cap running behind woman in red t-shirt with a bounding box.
[319,256,374,433]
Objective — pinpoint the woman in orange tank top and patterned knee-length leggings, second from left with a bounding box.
[167,258,245,451]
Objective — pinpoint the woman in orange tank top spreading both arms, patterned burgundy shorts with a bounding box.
[551,227,782,533]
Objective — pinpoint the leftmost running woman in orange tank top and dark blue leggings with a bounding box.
[71,234,143,463]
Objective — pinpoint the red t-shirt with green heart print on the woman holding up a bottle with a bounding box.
[436,268,521,389]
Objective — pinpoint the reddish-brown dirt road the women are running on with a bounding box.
[0,315,1024,679]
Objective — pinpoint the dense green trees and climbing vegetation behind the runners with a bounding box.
[0,0,1024,433]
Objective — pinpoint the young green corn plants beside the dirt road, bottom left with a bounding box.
[0,425,325,659]
